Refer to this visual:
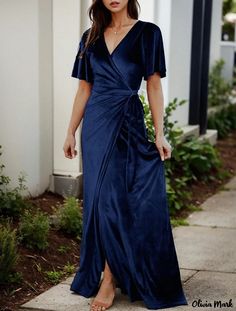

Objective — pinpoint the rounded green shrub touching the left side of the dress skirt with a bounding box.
[56,196,82,236]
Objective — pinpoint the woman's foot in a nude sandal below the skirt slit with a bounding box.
[90,279,116,311]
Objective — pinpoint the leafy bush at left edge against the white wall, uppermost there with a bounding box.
[0,145,31,218]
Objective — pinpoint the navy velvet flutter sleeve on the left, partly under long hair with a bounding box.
[71,28,93,83]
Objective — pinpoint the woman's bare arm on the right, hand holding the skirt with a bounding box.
[147,73,171,161]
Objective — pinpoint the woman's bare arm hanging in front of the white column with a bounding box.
[63,80,92,159]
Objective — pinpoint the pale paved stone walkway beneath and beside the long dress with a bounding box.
[21,177,236,311]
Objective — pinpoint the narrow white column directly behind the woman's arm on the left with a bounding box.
[53,0,81,177]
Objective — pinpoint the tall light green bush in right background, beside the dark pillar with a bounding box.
[208,59,231,107]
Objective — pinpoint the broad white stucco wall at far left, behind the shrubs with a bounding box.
[0,0,52,195]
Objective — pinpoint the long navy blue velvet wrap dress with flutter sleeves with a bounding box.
[70,20,188,309]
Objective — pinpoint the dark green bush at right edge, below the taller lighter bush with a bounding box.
[207,104,236,138]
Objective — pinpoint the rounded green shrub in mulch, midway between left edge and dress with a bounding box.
[19,210,50,250]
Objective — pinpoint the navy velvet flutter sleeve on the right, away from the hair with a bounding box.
[143,22,166,80]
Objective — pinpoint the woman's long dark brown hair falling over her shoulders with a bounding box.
[81,0,140,54]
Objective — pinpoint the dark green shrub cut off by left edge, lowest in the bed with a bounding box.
[0,223,19,284]
